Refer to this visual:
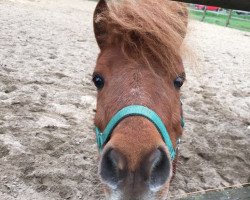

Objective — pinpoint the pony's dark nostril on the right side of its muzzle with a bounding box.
[144,148,171,191]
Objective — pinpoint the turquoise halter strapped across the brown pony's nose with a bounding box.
[95,105,184,160]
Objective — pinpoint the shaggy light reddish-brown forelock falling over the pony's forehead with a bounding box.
[100,0,188,71]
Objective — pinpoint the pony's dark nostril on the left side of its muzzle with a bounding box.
[100,149,126,189]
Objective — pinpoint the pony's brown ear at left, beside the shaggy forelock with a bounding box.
[93,0,108,49]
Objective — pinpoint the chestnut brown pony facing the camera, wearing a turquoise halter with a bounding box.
[93,0,188,200]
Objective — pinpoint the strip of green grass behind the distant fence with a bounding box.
[189,10,250,32]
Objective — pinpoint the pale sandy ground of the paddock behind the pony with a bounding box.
[0,0,250,200]
